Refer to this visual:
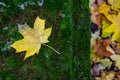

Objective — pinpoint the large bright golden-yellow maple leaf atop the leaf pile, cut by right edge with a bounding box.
[99,3,120,41]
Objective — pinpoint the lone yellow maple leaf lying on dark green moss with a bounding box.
[11,17,52,60]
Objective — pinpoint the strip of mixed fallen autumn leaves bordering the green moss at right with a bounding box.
[89,0,120,80]
